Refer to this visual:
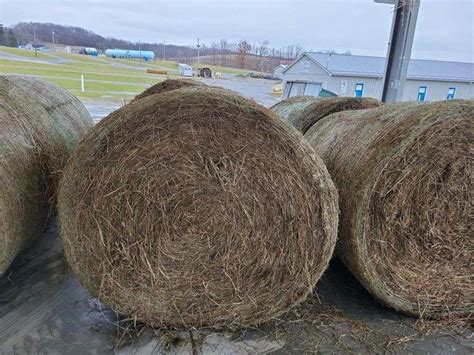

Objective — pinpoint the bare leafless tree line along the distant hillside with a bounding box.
[8,22,303,72]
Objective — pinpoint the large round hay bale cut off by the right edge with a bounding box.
[305,101,474,317]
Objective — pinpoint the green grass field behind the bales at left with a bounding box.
[0,46,256,100]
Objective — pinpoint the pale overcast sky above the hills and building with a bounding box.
[0,0,474,62]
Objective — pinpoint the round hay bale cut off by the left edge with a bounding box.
[0,75,92,276]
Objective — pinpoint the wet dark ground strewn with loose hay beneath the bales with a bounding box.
[0,222,474,354]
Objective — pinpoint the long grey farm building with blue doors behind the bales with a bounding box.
[282,52,474,102]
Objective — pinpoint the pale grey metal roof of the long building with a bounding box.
[283,52,474,82]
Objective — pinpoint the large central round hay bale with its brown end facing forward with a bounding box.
[58,87,338,328]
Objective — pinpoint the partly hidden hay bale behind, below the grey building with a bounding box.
[271,96,382,134]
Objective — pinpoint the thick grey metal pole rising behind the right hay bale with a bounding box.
[374,0,420,102]
